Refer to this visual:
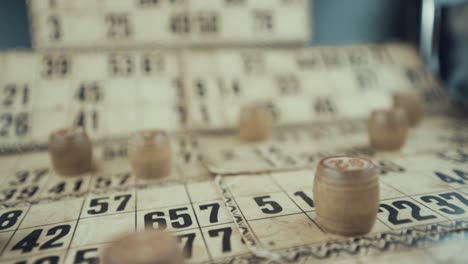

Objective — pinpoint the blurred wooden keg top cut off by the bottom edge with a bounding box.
[103,230,184,264]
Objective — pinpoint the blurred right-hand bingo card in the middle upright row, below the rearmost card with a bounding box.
[182,44,450,130]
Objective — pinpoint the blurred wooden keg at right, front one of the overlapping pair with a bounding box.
[367,108,409,150]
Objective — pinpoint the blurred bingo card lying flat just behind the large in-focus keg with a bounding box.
[199,116,468,175]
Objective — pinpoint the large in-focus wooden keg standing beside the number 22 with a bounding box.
[313,156,379,236]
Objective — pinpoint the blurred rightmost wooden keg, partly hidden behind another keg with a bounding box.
[393,92,424,127]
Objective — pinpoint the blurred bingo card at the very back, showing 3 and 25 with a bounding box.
[29,0,310,48]
